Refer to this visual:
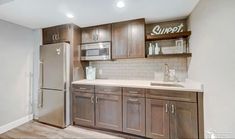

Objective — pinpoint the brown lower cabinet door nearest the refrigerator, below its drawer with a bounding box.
[73,92,95,126]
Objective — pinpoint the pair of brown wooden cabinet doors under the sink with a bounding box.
[146,99,198,139]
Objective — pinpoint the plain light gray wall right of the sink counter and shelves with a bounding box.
[189,0,235,138]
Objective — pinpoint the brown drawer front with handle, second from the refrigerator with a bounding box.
[95,86,122,95]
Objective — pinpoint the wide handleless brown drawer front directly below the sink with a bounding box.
[146,89,197,102]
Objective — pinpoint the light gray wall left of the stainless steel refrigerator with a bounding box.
[0,20,35,126]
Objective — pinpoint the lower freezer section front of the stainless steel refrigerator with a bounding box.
[38,89,66,128]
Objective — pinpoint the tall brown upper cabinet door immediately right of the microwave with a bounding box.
[112,22,128,59]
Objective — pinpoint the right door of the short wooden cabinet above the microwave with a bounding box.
[97,25,111,42]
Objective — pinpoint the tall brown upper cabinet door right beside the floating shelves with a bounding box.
[128,19,145,58]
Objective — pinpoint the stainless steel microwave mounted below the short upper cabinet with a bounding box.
[81,42,111,61]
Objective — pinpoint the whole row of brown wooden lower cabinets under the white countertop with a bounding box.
[73,85,203,139]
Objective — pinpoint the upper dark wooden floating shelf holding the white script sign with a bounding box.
[146,31,191,41]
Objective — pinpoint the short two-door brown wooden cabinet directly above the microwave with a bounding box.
[82,25,111,43]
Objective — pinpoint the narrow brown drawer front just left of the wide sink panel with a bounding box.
[123,88,145,97]
